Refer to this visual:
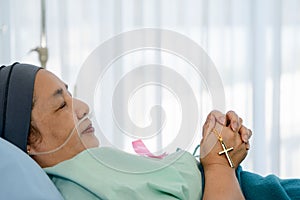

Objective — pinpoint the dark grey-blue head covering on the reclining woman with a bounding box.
[0,63,40,152]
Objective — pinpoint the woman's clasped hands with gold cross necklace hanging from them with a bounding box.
[200,111,252,168]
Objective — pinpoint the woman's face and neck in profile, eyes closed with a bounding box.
[27,70,99,167]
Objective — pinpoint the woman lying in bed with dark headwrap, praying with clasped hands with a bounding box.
[0,63,300,199]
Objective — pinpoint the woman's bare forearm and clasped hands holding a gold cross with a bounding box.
[201,111,250,199]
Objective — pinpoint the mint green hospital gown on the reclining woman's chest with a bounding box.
[44,147,202,200]
